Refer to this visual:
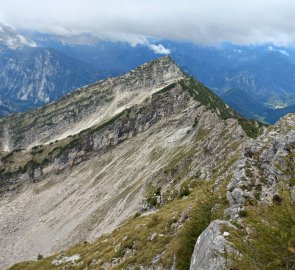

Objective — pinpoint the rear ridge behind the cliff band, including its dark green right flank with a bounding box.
[0,57,261,153]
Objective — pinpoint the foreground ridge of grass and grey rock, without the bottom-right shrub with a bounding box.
[5,108,295,270]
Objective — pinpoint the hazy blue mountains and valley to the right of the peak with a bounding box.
[165,42,295,123]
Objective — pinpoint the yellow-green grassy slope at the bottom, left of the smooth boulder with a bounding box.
[10,180,227,270]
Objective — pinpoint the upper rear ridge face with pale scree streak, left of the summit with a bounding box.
[1,58,185,152]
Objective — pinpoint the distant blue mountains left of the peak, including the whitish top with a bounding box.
[0,26,106,115]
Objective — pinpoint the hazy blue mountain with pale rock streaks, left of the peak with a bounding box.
[0,48,104,107]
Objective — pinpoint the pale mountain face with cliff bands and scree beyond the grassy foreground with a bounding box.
[0,58,254,267]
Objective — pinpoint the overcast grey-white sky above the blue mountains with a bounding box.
[0,0,295,45]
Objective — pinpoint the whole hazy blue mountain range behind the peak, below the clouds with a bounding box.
[0,24,295,123]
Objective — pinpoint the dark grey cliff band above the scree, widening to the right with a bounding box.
[0,79,247,193]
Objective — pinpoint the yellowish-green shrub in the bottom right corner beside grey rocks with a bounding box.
[230,151,295,270]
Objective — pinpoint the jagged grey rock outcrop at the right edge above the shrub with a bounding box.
[226,114,295,218]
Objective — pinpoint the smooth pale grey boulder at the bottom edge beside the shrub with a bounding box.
[190,220,234,270]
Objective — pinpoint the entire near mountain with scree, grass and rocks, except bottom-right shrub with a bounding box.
[0,57,295,270]
